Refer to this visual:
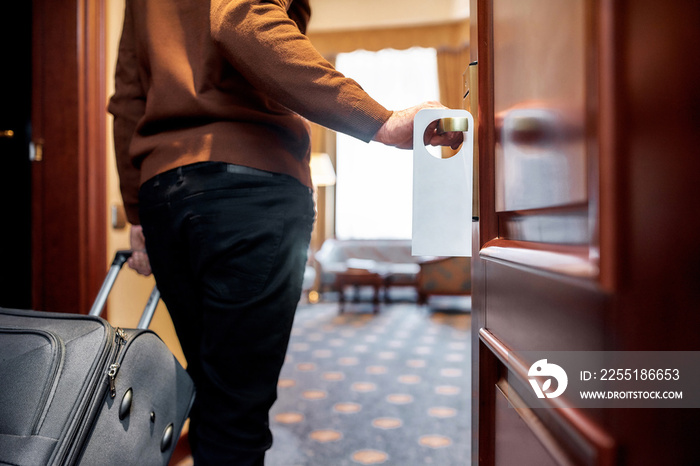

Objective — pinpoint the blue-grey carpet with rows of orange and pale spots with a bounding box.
[266,303,471,466]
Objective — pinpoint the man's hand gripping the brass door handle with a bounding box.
[374,102,464,149]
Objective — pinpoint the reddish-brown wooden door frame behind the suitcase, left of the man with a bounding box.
[32,0,107,313]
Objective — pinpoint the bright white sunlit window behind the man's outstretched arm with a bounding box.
[336,48,440,239]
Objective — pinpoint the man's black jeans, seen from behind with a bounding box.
[139,162,314,465]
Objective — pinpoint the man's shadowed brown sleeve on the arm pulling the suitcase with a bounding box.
[108,2,146,225]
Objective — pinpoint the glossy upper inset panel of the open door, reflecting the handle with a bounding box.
[493,0,588,212]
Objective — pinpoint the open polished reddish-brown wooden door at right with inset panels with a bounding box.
[471,0,700,465]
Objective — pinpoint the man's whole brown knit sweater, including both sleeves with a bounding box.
[108,0,391,224]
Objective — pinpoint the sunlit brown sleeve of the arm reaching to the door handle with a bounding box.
[210,0,391,141]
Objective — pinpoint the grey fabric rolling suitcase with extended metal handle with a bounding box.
[0,251,195,466]
